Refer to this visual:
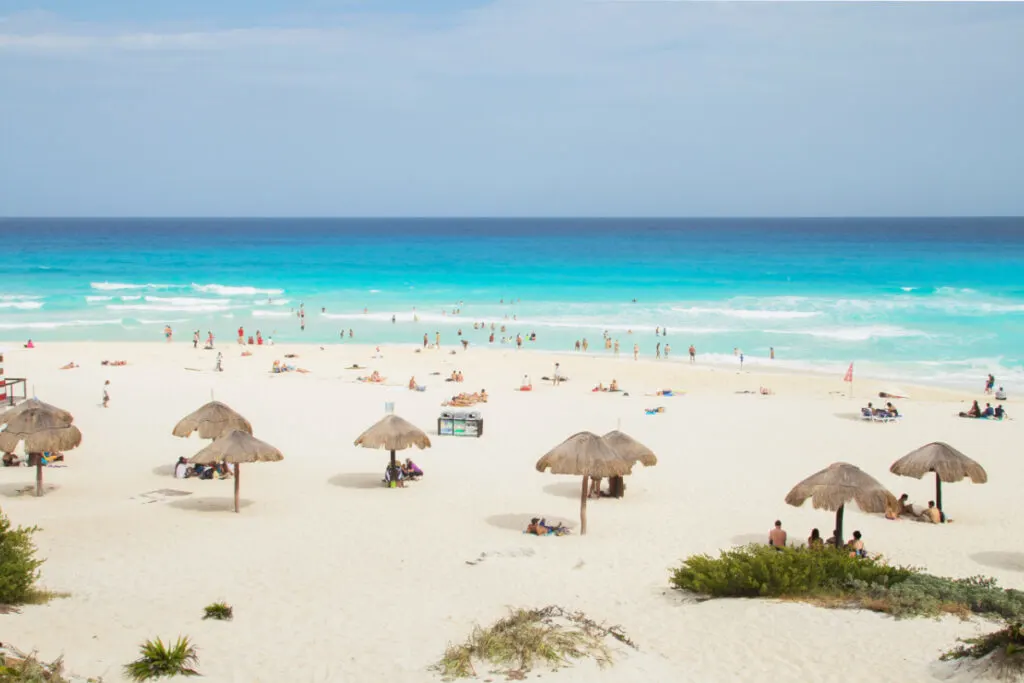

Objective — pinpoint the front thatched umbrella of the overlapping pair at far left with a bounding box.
[0,401,82,497]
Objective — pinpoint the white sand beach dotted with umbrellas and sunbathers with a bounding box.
[0,340,1024,683]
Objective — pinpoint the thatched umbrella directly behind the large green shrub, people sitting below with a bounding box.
[785,463,897,548]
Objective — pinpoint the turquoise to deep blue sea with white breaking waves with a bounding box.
[0,218,1024,390]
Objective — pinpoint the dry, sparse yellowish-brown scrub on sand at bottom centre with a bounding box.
[432,605,636,680]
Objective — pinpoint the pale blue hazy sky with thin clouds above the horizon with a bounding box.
[0,0,1024,216]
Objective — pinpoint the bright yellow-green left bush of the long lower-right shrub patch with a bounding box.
[670,545,914,597]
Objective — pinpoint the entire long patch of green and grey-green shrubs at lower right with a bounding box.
[670,545,1024,620]
